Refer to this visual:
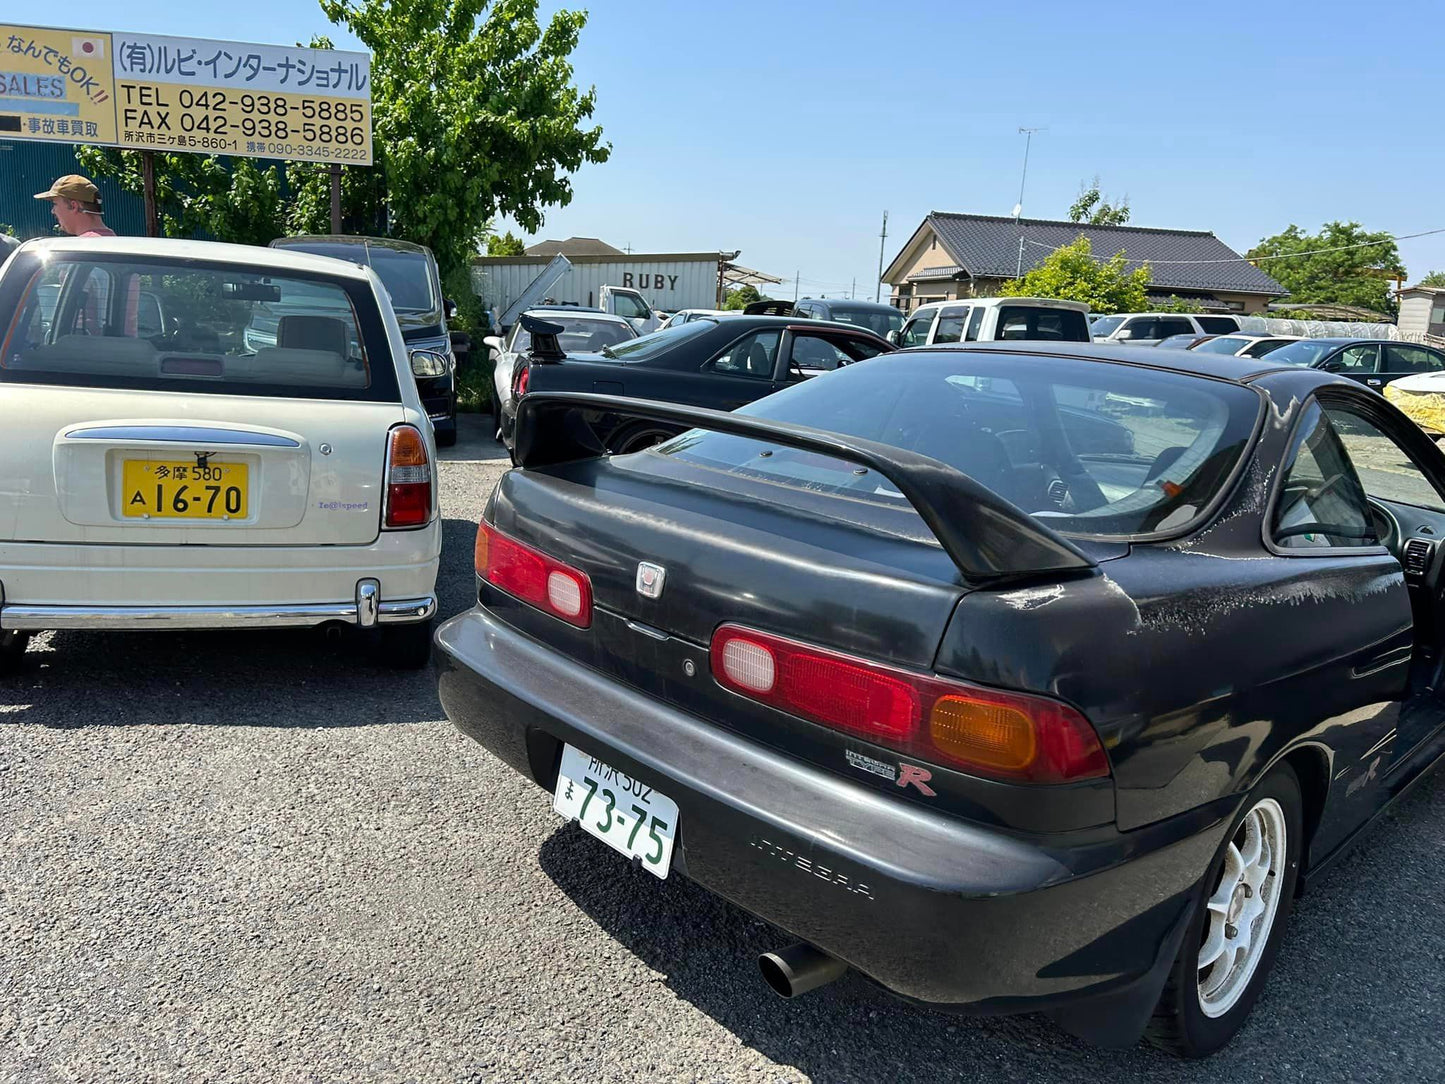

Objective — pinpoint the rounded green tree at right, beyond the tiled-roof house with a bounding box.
[1246,223,1405,315]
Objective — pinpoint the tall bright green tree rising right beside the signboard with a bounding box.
[288,0,611,284]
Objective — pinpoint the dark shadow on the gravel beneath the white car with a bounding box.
[0,519,477,727]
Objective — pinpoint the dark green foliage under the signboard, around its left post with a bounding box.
[75,146,283,244]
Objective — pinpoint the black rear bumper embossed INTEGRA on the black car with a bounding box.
[435,607,1224,1042]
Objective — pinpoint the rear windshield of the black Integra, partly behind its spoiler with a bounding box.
[656,351,1260,538]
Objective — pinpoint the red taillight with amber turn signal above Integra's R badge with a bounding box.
[711,624,1108,783]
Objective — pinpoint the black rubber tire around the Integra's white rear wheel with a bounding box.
[1144,765,1305,1058]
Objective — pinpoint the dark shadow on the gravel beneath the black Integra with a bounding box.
[539,775,1445,1084]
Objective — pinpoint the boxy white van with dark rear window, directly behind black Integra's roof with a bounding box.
[889,298,1092,347]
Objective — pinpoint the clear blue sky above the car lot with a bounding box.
[38,0,1445,296]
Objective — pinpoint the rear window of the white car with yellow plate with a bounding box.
[0,253,399,402]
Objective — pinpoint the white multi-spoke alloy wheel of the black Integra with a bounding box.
[1198,798,1289,1018]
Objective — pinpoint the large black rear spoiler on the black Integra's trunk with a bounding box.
[513,392,1097,581]
